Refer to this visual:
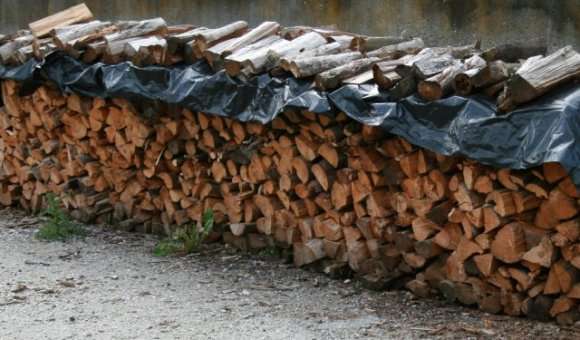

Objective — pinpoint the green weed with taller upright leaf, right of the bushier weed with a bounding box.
[153,209,214,256]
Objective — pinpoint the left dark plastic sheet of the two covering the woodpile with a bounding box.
[0,53,331,124]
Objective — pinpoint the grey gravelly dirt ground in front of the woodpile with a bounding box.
[0,210,580,340]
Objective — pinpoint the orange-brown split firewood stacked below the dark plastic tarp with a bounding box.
[0,77,580,324]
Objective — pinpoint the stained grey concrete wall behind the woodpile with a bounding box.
[0,0,580,50]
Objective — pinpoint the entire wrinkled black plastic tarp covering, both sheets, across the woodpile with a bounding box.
[0,53,580,186]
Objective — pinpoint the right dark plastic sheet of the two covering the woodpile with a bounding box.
[329,84,580,186]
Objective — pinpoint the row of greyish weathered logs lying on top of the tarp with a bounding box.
[0,4,580,112]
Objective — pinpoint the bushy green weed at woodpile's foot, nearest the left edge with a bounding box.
[36,193,85,241]
